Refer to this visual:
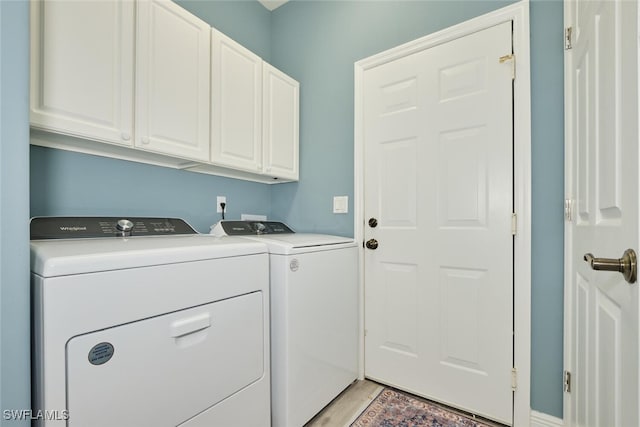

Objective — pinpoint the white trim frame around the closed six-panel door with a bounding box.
[354,0,531,427]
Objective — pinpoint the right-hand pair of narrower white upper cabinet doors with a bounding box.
[211,29,299,181]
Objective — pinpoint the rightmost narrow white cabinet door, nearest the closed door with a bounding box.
[262,63,300,180]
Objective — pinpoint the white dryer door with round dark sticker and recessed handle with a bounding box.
[67,292,269,427]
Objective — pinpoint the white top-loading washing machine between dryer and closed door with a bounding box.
[211,221,358,427]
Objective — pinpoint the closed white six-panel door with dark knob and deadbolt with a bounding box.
[363,22,513,424]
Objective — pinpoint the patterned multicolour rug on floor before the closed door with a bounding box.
[351,387,494,427]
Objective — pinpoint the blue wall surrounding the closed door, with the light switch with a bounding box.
[271,0,564,417]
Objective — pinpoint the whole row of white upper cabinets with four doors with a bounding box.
[28,0,299,183]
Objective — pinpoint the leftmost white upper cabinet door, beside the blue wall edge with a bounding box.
[31,0,134,145]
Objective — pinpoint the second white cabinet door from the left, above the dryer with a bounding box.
[135,0,211,160]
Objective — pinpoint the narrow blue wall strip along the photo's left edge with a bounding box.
[0,1,31,426]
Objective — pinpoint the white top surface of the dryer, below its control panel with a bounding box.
[31,234,267,277]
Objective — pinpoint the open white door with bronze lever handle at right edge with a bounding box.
[565,0,640,427]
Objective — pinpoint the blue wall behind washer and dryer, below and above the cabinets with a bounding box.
[30,0,271,232]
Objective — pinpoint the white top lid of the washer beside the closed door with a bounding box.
[246,233,356,255]
